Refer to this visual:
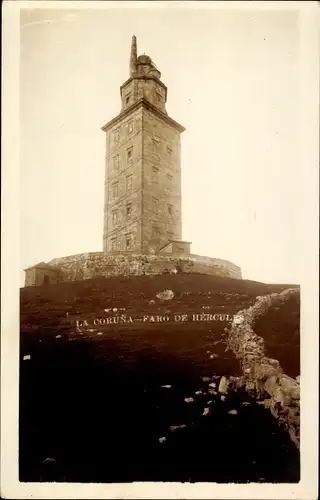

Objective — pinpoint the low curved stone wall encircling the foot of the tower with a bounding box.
[49,252,241,281]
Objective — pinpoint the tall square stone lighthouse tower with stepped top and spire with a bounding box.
[102,36,185,254]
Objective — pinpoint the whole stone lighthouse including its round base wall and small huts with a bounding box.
[25,36,241,286]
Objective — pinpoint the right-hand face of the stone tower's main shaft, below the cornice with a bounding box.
[142,109,182,253]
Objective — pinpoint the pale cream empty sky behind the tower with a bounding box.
[20,2,310,283]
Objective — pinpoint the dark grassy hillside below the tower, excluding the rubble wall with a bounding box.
[20,274,299,482]
